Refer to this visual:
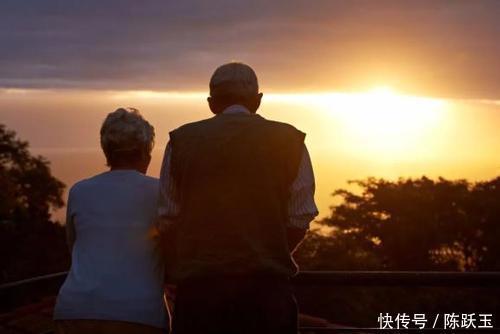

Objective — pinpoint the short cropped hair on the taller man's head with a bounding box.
[210,62,259,98]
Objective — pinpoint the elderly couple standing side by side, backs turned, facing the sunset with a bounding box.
[54,63,318,334]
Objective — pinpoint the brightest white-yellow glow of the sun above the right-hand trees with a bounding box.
[314,87,446,160]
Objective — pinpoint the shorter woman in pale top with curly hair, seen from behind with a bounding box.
[54,108,168,333]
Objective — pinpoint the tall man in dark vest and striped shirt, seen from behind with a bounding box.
[159,63,318,334]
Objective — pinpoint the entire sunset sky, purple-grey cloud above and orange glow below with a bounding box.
[0,0,500,220]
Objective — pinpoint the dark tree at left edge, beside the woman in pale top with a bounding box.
[0,124,68,281]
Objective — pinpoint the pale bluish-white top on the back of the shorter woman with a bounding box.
[54,170,167,327]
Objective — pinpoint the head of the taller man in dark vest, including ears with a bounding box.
[207,62,262,114]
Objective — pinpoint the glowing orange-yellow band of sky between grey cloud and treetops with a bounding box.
[0,88,500,222]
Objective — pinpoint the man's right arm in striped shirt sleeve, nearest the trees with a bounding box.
[287,144,318,253]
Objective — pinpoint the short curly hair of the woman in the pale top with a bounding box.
[101,108,155,162]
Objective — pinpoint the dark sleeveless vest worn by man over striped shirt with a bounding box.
[167,114,305,281]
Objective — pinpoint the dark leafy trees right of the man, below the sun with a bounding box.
[297,177,500,271]
